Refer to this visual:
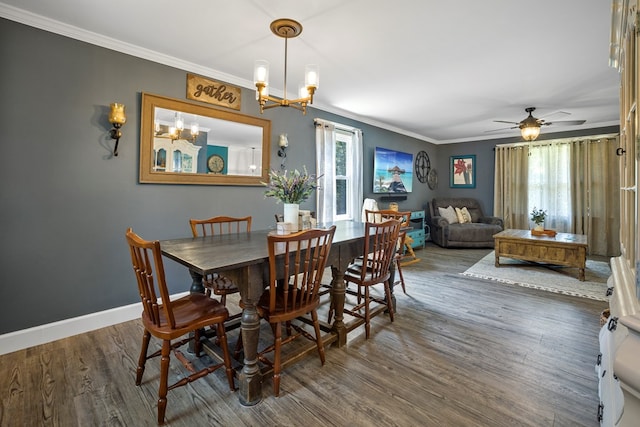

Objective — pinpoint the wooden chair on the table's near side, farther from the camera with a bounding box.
[336,219,400,339]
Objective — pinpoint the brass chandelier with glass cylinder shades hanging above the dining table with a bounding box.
[253,19,320,114]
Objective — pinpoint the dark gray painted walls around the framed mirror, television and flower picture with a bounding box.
[0,19,620,334]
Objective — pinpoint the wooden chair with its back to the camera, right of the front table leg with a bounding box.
[257,225,336,396]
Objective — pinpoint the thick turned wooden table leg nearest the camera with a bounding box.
[238,302,262,406]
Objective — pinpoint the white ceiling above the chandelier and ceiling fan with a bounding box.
[0,0,619,144]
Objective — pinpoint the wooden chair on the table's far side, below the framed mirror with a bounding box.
[189,216,252,310]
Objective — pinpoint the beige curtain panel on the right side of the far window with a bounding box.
[571,137,620,256]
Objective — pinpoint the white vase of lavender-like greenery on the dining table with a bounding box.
[262,166,320,231]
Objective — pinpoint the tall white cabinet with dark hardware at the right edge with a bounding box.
[596,0,640,427]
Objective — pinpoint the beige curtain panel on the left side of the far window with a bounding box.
[493,145,529,230]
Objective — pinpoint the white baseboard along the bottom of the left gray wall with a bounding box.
[0,292,189,355]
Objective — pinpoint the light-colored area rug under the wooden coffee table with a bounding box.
[461,252,611,301]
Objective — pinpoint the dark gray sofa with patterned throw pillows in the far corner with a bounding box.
[429,197,504,248]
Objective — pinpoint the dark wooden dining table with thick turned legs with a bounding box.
[160,221,395,406]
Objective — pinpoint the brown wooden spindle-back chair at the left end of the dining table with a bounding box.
[126,228,235,424]
